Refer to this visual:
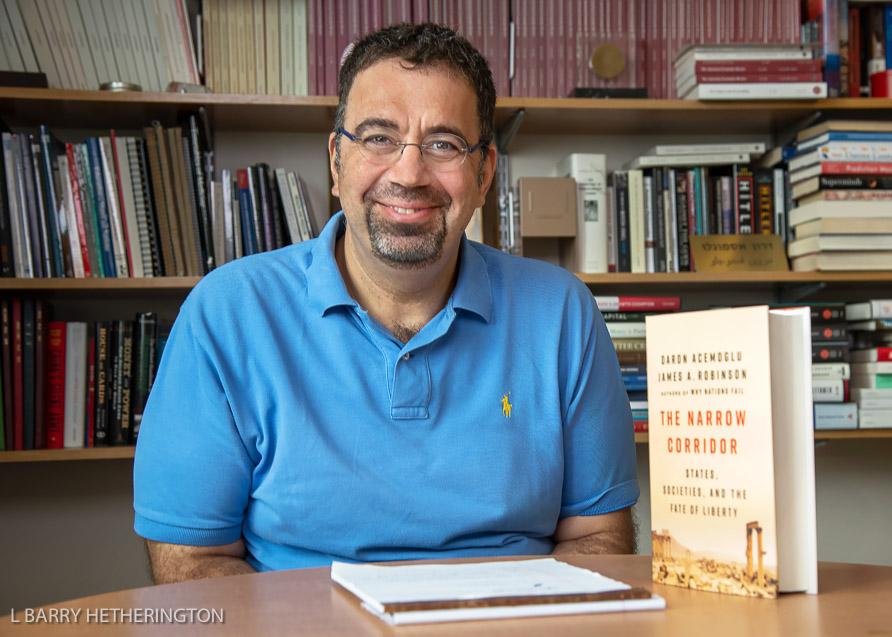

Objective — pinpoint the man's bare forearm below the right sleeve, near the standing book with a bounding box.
[552,509,635,555]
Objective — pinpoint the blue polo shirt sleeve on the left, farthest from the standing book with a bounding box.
[133,299,254,546]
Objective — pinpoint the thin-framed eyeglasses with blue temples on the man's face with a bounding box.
[335,128,486,172]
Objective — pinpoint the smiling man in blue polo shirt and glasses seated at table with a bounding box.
[134,25,638,582]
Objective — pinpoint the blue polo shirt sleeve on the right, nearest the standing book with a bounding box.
[560,290,640,518]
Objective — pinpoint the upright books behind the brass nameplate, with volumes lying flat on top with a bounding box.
[605,142,787,272]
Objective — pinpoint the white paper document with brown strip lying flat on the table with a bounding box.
[331,558,666,624]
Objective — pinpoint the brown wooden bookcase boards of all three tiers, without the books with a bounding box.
[0,88,892,462]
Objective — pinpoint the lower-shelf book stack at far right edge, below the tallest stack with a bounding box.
[846,299,892,429]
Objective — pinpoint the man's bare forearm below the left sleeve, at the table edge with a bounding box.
[146,540,255,584]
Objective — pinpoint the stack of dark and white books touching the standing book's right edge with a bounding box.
[809,302,858,429]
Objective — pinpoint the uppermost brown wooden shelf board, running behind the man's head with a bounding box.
[0,88,892,135]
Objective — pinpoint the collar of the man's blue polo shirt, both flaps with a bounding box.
[307,211,492,322]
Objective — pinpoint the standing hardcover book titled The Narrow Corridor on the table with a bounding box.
[646,306,817,597]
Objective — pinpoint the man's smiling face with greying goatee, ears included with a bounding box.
[329,59,495,268]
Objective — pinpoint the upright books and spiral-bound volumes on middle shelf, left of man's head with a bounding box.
[0,115,318,278]
